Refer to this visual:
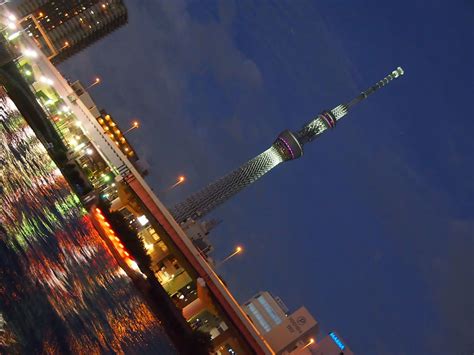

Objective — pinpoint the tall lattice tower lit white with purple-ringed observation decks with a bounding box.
[170,67,403,223]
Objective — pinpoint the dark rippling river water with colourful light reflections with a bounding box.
[0,93,175,354]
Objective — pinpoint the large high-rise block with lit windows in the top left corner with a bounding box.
[14,0,128,64]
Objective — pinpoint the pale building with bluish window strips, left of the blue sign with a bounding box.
[242,291,319,355]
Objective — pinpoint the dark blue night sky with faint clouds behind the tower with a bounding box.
[61,0,474,354]
